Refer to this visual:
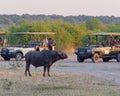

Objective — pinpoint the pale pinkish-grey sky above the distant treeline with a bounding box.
[0,0,120,17]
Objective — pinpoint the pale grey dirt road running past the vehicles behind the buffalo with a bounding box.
[0,53,120,85]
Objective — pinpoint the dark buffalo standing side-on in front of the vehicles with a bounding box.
[25,50,68,76]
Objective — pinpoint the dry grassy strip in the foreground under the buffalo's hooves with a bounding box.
[0,67,120,96]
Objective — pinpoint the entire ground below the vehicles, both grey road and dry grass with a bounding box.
[0,53,120,96]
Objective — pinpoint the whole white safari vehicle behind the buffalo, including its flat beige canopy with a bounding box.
[1,32,55,61]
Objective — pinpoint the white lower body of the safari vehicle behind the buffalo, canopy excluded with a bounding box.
[1,46,44,61]
